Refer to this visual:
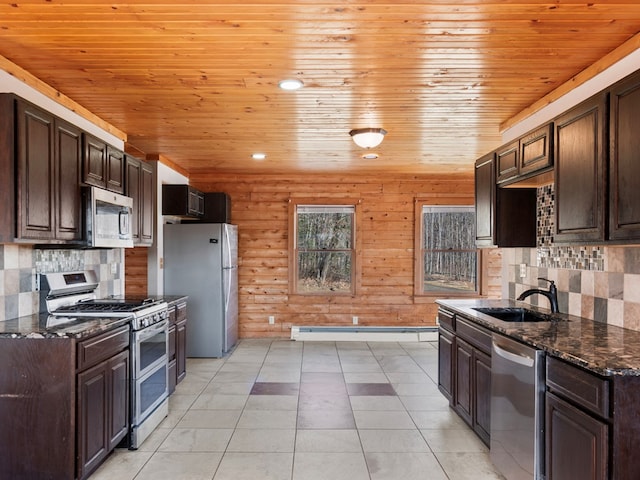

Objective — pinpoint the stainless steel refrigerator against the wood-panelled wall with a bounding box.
[164,223,238,357]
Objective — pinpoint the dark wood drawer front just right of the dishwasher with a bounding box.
[547,357,610,418]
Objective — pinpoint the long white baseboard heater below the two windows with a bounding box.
[291,325,438,342]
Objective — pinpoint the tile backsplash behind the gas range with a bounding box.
[0,244,124,321]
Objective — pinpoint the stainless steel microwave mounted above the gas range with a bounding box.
[84,187,133,248]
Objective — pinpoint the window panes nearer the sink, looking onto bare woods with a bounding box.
[416,205,478,295]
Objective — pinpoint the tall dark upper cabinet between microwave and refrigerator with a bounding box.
[125,155,155,246]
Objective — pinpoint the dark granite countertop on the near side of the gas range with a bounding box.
[0,313,131,339]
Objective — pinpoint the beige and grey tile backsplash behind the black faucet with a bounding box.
[510,185,640,330]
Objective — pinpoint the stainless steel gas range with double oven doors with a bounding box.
[41,271,169,449]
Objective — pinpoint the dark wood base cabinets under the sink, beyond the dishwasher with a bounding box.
[438,309,491,445]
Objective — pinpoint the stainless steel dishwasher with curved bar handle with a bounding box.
[490,333,545,480]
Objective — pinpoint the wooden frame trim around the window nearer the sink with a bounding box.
[413,194,483,298]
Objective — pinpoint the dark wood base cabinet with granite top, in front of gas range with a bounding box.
[0,314,130,480]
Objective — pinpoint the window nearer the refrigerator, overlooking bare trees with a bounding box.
[291,203,356,295]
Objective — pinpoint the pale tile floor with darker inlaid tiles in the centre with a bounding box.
[90,339,503,480]
